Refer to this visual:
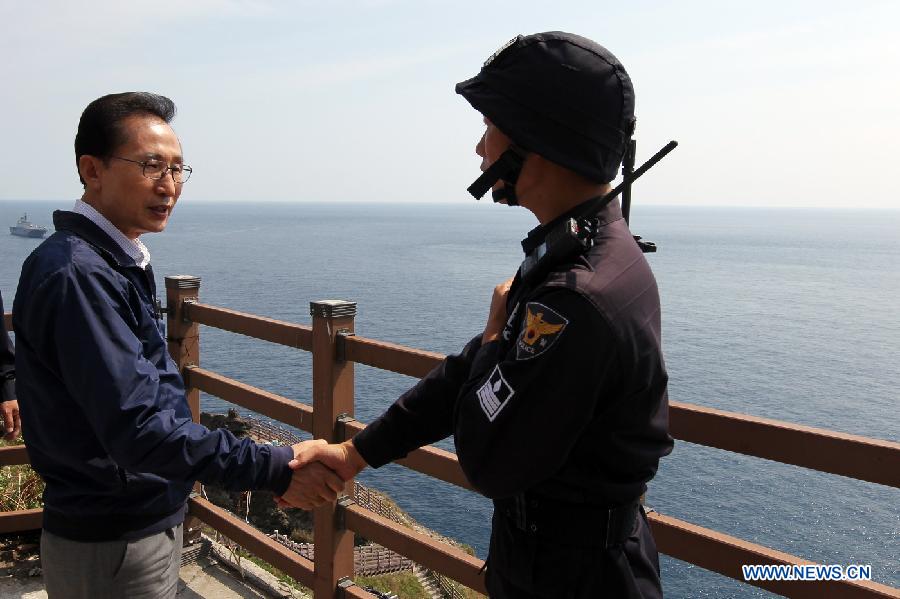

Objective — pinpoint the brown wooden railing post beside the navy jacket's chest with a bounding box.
[166,275,200,545]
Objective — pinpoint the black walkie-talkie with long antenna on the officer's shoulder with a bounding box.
[519,140,678,282]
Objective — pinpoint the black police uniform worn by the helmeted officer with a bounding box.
[354,202,672,598]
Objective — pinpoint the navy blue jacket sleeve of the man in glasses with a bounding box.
[23,268,293,494]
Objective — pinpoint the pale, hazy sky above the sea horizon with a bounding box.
[0,0,900,209]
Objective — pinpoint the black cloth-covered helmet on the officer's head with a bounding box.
[456,31,634,183]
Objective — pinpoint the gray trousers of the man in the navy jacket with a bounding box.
[41,524,183,599]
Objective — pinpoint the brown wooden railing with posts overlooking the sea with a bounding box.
[0,276,900,598]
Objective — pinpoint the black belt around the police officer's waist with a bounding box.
[494,495,641,547]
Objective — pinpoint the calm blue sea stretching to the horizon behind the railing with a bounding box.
[0,198,900,598]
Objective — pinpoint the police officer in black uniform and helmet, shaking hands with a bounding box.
[297,32,672,599]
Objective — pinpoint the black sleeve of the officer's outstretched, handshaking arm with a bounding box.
[353,335,481,468]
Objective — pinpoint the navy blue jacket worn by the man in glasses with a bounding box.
[13,211,293,541]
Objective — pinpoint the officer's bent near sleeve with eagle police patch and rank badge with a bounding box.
[454,289,618,498]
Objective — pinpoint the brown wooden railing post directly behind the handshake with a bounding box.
[309,300,356,599]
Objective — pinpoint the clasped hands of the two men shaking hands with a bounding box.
[275,439,368,510]
